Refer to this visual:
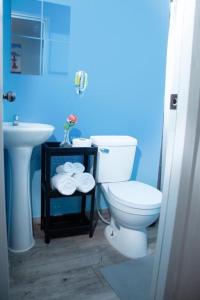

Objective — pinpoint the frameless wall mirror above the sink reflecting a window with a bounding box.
[10,0,71,75]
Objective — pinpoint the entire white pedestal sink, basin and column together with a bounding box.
[3,122,54,252]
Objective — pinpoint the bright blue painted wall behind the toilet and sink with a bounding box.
[4,0,169,216]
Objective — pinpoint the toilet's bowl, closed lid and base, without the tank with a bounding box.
[101,181,162,258]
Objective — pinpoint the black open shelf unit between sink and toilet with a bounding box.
[41,142,98,244]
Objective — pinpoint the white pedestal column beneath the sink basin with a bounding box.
[8,147,34,252]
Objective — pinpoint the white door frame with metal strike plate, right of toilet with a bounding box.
[151,0,200,300]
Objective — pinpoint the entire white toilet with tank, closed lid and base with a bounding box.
[91,136,162,258]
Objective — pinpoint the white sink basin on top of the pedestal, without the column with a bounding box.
[3,122,54,148]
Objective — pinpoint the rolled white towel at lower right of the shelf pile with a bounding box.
[73,173,95,193]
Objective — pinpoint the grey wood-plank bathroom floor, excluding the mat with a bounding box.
[9,223,157,300]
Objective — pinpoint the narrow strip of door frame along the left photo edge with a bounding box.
[0,0,9,300]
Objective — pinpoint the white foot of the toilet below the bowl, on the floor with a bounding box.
[104,222,147,258]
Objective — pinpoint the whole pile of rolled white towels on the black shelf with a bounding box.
[51,162,95,196]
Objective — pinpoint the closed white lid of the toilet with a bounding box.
[108,181,162,209]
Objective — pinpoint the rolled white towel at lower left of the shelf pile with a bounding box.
[51,173,76,196]
